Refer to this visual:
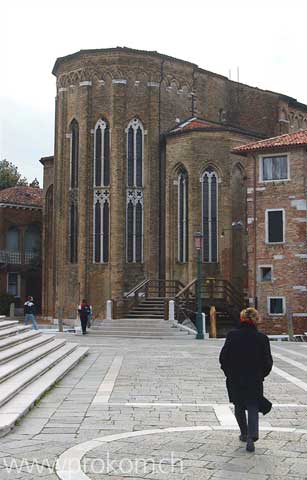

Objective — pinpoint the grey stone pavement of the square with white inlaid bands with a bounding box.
[0,334,307,480]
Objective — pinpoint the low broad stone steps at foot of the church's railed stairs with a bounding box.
[90,317,187,339]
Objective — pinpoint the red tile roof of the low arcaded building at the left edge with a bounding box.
[0,187,43,208]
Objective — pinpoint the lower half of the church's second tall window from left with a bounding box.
[94,190,110,263]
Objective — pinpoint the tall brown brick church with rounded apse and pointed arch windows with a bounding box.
[41,48,307,330]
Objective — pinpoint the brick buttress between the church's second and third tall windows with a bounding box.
[110,79,127,316]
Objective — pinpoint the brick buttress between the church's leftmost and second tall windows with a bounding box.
[78,80,92,301]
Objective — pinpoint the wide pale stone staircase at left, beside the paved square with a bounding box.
[0,318,88,436]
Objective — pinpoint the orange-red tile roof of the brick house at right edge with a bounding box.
[232,130,307,155]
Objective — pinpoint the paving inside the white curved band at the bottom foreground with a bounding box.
[56,426,307,480]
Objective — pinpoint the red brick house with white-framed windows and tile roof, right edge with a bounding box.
[234,130,307,334]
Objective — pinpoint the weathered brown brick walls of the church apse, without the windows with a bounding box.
[44,49,307,318]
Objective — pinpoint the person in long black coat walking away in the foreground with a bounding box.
[220,308,273,452]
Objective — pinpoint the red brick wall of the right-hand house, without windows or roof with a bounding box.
[247,147,307,333]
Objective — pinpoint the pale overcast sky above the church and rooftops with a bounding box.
[0,0,307,186]
